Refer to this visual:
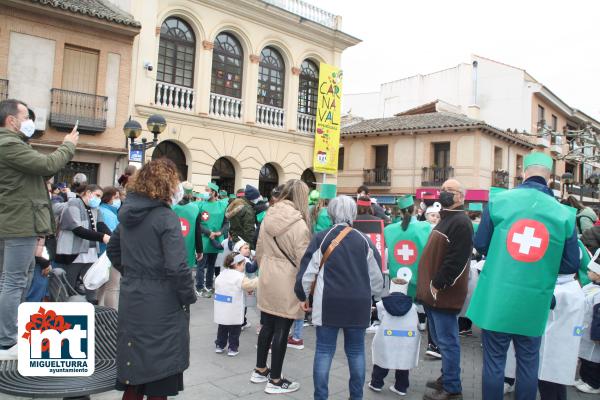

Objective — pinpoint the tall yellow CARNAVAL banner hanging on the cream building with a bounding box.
[313,63,343,174]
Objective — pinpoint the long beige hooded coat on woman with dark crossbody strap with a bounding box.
[256,200,310,319]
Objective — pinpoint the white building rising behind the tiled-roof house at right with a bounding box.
[344,56,600,196]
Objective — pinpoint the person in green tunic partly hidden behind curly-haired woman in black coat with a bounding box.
[172,182,202,268]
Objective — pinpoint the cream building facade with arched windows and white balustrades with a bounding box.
[114,0,359,195]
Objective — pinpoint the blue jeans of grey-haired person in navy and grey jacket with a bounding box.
[313,326,365,400]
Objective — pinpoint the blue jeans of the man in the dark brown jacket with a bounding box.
[425,307,462,393]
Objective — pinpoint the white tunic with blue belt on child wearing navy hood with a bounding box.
[371,301,421,370]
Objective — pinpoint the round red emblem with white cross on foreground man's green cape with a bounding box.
[506,219,550,262]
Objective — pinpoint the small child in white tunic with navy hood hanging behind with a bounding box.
[369,267,421,396]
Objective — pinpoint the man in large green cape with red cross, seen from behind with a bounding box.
[467,152,580,400]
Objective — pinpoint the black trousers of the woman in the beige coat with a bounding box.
[256,312,294,379]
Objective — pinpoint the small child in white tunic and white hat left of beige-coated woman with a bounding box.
[214,252,258,357]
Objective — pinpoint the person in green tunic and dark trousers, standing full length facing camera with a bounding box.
[196,182,229,298]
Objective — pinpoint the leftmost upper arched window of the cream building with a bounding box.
[156,17,196,87]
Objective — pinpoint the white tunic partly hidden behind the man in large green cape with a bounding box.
[504,275,584,385]
